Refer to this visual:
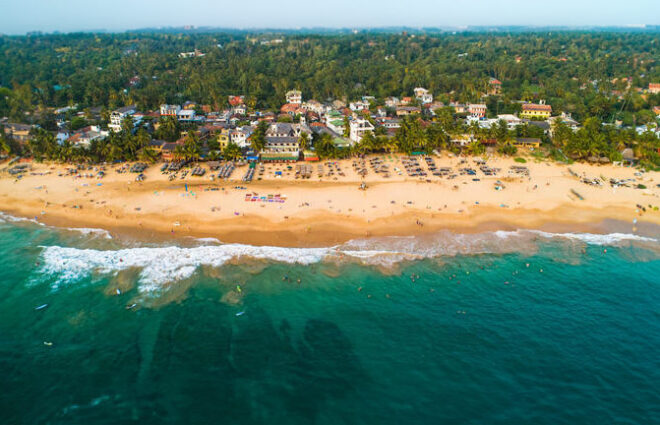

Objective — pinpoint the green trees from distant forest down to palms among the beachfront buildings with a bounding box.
[0,31,660,168]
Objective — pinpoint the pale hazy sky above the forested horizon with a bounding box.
[0,0,660,34]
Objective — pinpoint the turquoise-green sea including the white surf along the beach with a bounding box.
[0,216,660,424]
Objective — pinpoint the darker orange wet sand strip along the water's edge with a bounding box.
[0,188,660,248]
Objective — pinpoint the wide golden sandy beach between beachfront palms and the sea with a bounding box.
[0,155,660,246]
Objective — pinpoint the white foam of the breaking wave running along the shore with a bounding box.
[41,230,658,292]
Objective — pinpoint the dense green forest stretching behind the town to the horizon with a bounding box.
[0,31,660,124]
